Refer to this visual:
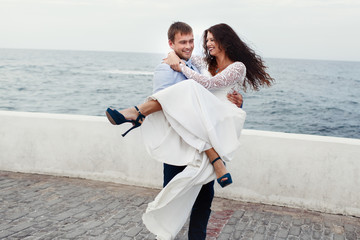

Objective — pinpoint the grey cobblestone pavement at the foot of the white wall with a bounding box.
[0,171,360,240]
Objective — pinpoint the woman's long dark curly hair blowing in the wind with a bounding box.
[203,23,274,90]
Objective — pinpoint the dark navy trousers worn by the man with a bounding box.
[163,163,214,240]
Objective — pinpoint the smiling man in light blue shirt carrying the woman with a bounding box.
[153,22,242,240]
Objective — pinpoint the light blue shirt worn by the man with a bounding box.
[153,59,200,93]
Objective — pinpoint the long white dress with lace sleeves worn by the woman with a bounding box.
[141,57,246,240]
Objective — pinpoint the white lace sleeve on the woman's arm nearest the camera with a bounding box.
[180,62,246,89]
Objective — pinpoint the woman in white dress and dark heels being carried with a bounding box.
[106,24,273,239]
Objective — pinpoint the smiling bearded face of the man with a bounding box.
[169,32,194,60]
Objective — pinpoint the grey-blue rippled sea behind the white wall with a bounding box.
[0,49,360,139]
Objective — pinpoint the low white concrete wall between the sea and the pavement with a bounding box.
[0,111,360,217]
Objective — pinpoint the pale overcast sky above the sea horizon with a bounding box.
[0,0,360,61]
